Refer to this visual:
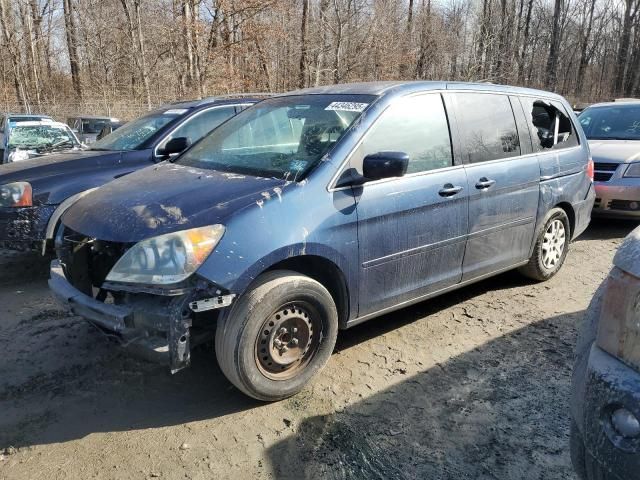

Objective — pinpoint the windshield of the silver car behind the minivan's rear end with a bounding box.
[578,104,640,140]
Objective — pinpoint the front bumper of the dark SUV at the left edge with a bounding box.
[0,205,57,250]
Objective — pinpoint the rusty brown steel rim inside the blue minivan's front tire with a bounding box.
[255,302,322,380]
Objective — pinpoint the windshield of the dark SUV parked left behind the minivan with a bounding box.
[91,108,188,150]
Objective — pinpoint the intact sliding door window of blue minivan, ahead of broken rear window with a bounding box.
[454,93,520,163]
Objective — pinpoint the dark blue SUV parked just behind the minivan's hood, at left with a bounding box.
[0,96,259,253]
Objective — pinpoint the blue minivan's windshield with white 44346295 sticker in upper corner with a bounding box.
[177,95,375,180]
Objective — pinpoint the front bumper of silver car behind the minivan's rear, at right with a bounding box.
[593,178,640,219]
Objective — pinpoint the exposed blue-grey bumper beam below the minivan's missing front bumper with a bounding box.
[49,260,175,370]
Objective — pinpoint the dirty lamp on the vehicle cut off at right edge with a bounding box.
[597,268,640,369]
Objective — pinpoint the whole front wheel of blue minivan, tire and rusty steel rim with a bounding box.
[216,270,338,401]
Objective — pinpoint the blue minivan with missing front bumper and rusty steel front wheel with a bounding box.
[49,82,594,400]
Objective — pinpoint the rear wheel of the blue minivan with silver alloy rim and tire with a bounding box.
[520,208,571,282]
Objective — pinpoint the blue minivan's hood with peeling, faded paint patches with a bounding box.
[62,162,285,243]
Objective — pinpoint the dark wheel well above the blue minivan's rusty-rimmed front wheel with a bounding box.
[267,255,349,328]
